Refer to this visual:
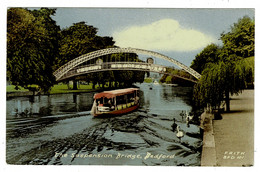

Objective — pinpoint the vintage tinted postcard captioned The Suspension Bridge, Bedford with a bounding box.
[5,0,255,167]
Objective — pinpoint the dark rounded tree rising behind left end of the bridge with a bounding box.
[56,22,115,89]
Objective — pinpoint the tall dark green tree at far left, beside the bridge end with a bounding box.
[7,8,59,92]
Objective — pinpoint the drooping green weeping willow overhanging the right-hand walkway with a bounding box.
[194,57,254,111]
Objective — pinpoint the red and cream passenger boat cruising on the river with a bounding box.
[91,88,139,117]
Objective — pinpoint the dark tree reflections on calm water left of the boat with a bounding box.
[6,93,93,119]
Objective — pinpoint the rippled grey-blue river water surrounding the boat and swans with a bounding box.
[6,83,202,166]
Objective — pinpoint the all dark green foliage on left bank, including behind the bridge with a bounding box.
[7,8,144,92]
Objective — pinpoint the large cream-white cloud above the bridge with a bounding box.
[113,19,215,51]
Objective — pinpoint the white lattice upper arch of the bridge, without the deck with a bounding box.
[53,48,201,81]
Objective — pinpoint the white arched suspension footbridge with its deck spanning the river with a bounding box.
[53,48,201,82]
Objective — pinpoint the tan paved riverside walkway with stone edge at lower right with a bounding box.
[201,90,254,166]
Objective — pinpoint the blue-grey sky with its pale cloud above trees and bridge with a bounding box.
[50,7,255,66]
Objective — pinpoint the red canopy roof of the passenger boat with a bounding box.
[94,88,139,99]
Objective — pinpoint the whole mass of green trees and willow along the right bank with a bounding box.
[194,17,254,111]
